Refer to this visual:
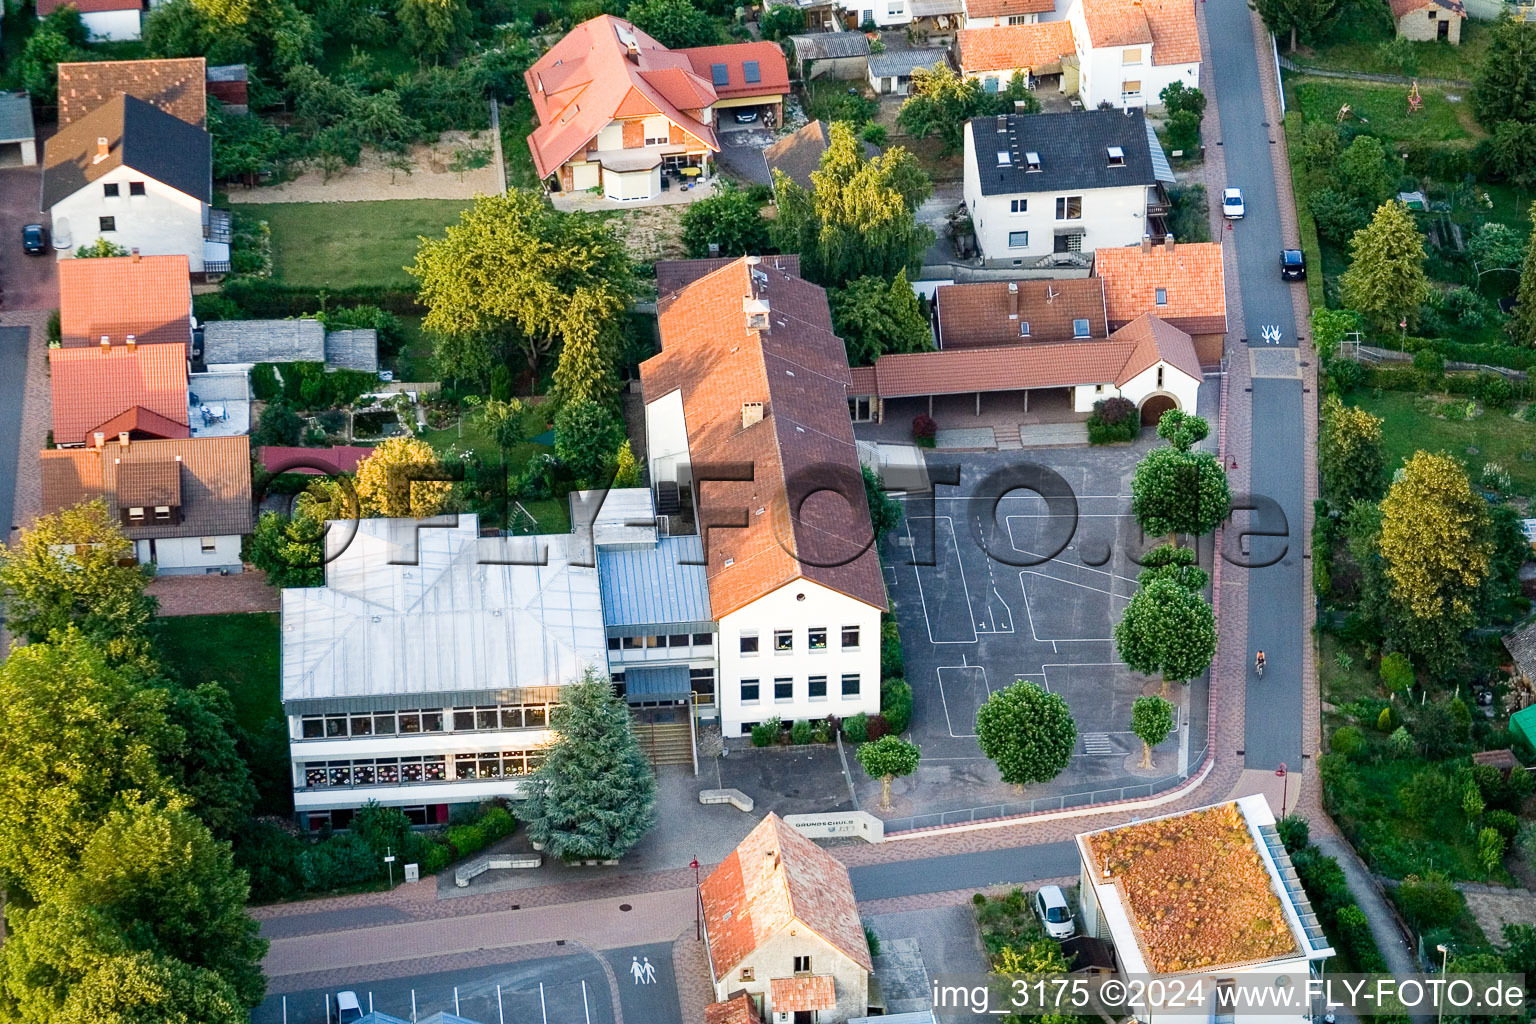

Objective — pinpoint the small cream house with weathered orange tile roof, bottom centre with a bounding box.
[699,814,872,1024]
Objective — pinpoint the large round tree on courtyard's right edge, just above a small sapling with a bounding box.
[1115,579,1217,697]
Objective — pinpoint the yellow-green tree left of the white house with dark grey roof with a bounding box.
[773,121,934,286]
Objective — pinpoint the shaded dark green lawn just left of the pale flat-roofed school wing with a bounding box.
[155,613,283,735]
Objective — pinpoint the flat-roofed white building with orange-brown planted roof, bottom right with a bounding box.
[1077,795,1333,1024]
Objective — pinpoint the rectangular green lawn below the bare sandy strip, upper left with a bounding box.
[241,200,470,289]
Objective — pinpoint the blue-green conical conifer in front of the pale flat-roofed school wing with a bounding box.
[524,671,656,860]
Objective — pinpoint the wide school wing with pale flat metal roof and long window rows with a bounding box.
[283,516,608,829]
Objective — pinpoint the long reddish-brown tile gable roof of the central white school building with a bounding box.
[641,259,886,619]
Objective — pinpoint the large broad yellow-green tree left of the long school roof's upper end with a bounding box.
[407,189,633,381]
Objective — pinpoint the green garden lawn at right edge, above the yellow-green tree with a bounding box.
[1349,388,1536,494]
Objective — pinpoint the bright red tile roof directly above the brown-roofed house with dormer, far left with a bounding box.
[48,342,190,444]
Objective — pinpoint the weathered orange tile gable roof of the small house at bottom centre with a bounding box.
[699,814,872,976]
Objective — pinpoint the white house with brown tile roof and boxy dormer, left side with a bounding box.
[40,436,255,576]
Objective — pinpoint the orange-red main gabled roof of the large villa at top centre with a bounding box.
[522,14,720,178]
